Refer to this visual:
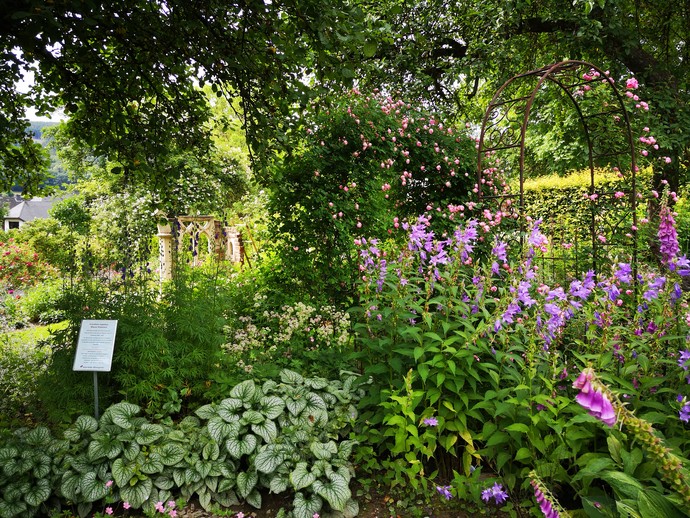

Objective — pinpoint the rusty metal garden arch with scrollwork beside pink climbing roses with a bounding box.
[477,60,637,278]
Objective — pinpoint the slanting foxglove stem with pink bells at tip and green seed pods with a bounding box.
[573,368,690,511]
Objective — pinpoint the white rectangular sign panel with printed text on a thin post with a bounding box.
[72,320,117,372]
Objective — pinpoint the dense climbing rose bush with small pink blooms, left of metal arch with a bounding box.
[270,91,474,300]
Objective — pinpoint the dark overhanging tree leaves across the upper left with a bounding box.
[0,0,374,192]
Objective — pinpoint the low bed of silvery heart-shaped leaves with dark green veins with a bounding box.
[0,370,362,518]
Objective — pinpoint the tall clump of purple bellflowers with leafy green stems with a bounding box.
[356,210,690,516]
